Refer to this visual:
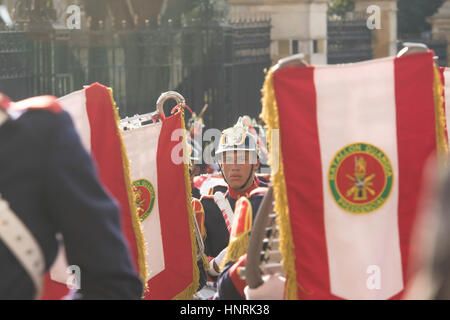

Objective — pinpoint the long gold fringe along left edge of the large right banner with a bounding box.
[260,67,302,300]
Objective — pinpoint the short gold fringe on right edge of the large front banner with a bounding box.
[433,66,448,168]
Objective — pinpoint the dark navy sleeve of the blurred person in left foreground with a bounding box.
[45,112,142,299]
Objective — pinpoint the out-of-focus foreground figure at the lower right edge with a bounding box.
[405,159,450,300]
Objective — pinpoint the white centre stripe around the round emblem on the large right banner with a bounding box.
[315,59,403,299]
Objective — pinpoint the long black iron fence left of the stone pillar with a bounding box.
[0,20,271,128]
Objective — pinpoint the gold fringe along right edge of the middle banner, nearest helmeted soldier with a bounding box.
[173,109,200,300]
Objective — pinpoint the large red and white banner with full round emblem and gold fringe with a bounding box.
[262,51,447,299]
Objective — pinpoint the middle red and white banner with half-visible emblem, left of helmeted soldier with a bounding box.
[122,111,199,300]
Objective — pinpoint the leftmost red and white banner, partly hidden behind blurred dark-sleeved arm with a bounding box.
[42,83,147,299]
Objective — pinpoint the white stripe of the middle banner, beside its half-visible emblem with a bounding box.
[122,122,164,279]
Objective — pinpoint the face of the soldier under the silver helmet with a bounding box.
[221,151,259,189]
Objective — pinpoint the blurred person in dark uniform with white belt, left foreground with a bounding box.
[0,95,142,299]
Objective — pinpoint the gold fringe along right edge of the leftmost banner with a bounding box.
[108,88,148,296]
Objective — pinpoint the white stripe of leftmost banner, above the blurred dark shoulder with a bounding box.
[58,90,91,152]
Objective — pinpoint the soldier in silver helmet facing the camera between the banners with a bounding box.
[201,119,267,286]
